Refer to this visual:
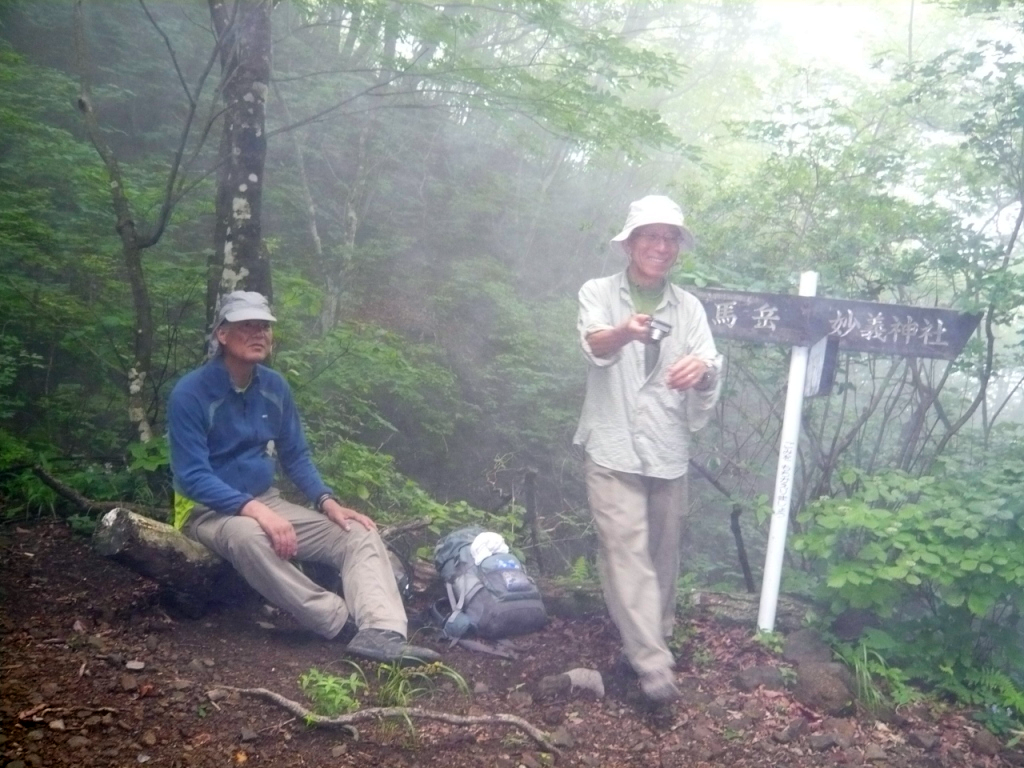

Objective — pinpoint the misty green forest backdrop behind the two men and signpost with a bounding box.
[0,0,1024,704]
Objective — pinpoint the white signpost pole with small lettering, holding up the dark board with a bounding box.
[758,272,818,632]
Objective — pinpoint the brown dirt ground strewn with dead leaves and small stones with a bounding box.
[0,523,1024,768]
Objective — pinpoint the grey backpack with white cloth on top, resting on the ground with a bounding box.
[434,525,548,640]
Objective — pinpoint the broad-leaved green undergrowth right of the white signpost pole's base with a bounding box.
[793,460,1024,718]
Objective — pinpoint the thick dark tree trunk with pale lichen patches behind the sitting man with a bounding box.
[207,0,272,323]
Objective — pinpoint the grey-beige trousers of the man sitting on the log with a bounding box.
[184,488,408,638]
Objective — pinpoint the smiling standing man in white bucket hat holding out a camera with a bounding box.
[573,195,721,705]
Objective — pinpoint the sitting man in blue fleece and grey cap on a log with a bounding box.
[168,291,439,662]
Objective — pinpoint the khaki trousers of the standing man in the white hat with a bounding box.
[584,456,687,675]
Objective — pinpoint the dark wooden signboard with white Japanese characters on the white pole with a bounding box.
[686,287,981,360]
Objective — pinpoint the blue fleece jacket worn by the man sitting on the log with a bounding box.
[168,356,331,515]
